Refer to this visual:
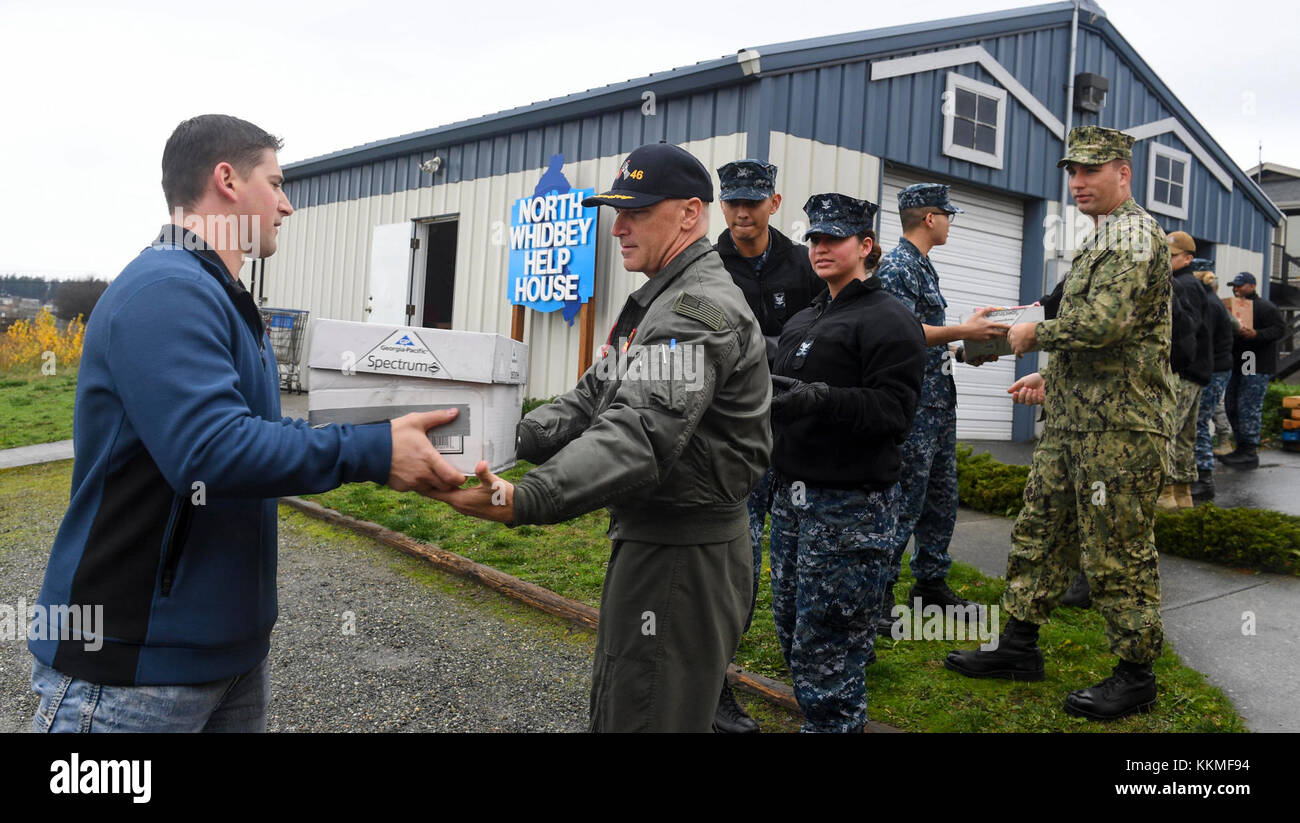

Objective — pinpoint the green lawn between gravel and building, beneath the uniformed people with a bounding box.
[311,464,1247,732]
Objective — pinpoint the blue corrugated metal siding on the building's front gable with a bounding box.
[759,27,1271,251]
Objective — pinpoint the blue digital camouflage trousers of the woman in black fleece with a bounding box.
[768,473,898,732]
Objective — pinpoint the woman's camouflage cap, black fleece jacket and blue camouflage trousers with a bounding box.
[770,194,924,732]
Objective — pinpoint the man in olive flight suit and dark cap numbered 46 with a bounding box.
[430,143,772,732]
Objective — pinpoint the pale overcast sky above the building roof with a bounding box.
[0,0,1300,277]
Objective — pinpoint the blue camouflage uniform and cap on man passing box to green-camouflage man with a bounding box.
[876,183,962,585]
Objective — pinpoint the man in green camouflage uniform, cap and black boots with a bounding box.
[944,126,1174,719]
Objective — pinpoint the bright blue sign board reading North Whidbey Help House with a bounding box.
[507,155,599,325]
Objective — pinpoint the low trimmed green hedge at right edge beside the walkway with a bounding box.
[1156,503,1300,575]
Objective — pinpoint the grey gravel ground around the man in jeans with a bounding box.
[0,462,594,732]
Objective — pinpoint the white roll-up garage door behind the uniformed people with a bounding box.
[880,163,1024,439]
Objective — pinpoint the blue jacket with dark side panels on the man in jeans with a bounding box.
[29,226,393,685]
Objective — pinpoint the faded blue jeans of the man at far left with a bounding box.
[31,658,270,733]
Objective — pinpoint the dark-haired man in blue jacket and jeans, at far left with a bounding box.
[29,114,465,732]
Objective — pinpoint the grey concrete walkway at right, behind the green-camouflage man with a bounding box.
[949,441,1300,732]
